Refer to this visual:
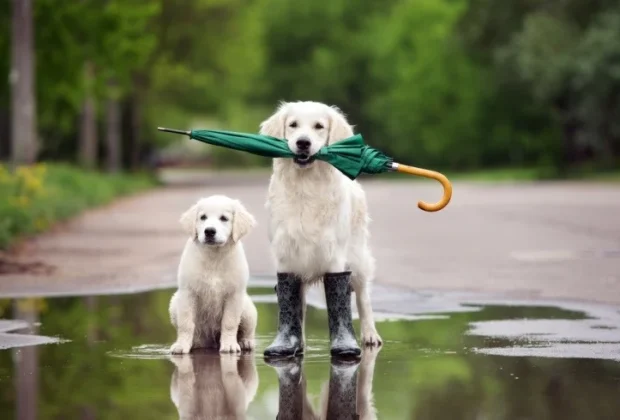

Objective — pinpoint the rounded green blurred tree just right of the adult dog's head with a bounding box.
[365,0,486,168]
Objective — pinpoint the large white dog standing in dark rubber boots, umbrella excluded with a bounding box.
[260,101,381,356]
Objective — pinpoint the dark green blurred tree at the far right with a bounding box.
[457,0,620,170]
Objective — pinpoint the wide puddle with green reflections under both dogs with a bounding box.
[0,281,620,420]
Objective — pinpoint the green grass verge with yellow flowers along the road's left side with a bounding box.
[0,164,155,249]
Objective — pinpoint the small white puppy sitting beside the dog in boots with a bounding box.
[170,195,257,353]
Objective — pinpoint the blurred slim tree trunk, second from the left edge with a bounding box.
[79,61,98,168]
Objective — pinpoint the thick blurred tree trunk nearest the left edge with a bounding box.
[10,0,38,164]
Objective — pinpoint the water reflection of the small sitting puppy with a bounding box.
[170,353,258,419]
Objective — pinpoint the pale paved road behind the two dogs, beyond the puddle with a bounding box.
[0,174,620,304]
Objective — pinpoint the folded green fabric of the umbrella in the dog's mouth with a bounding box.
[187,130,392,179]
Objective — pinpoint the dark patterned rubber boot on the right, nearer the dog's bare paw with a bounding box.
[323,271,362,357]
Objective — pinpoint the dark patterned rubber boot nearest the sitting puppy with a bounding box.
[264,273,303,357]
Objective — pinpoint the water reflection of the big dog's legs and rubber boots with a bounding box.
[267,347,380,420]
